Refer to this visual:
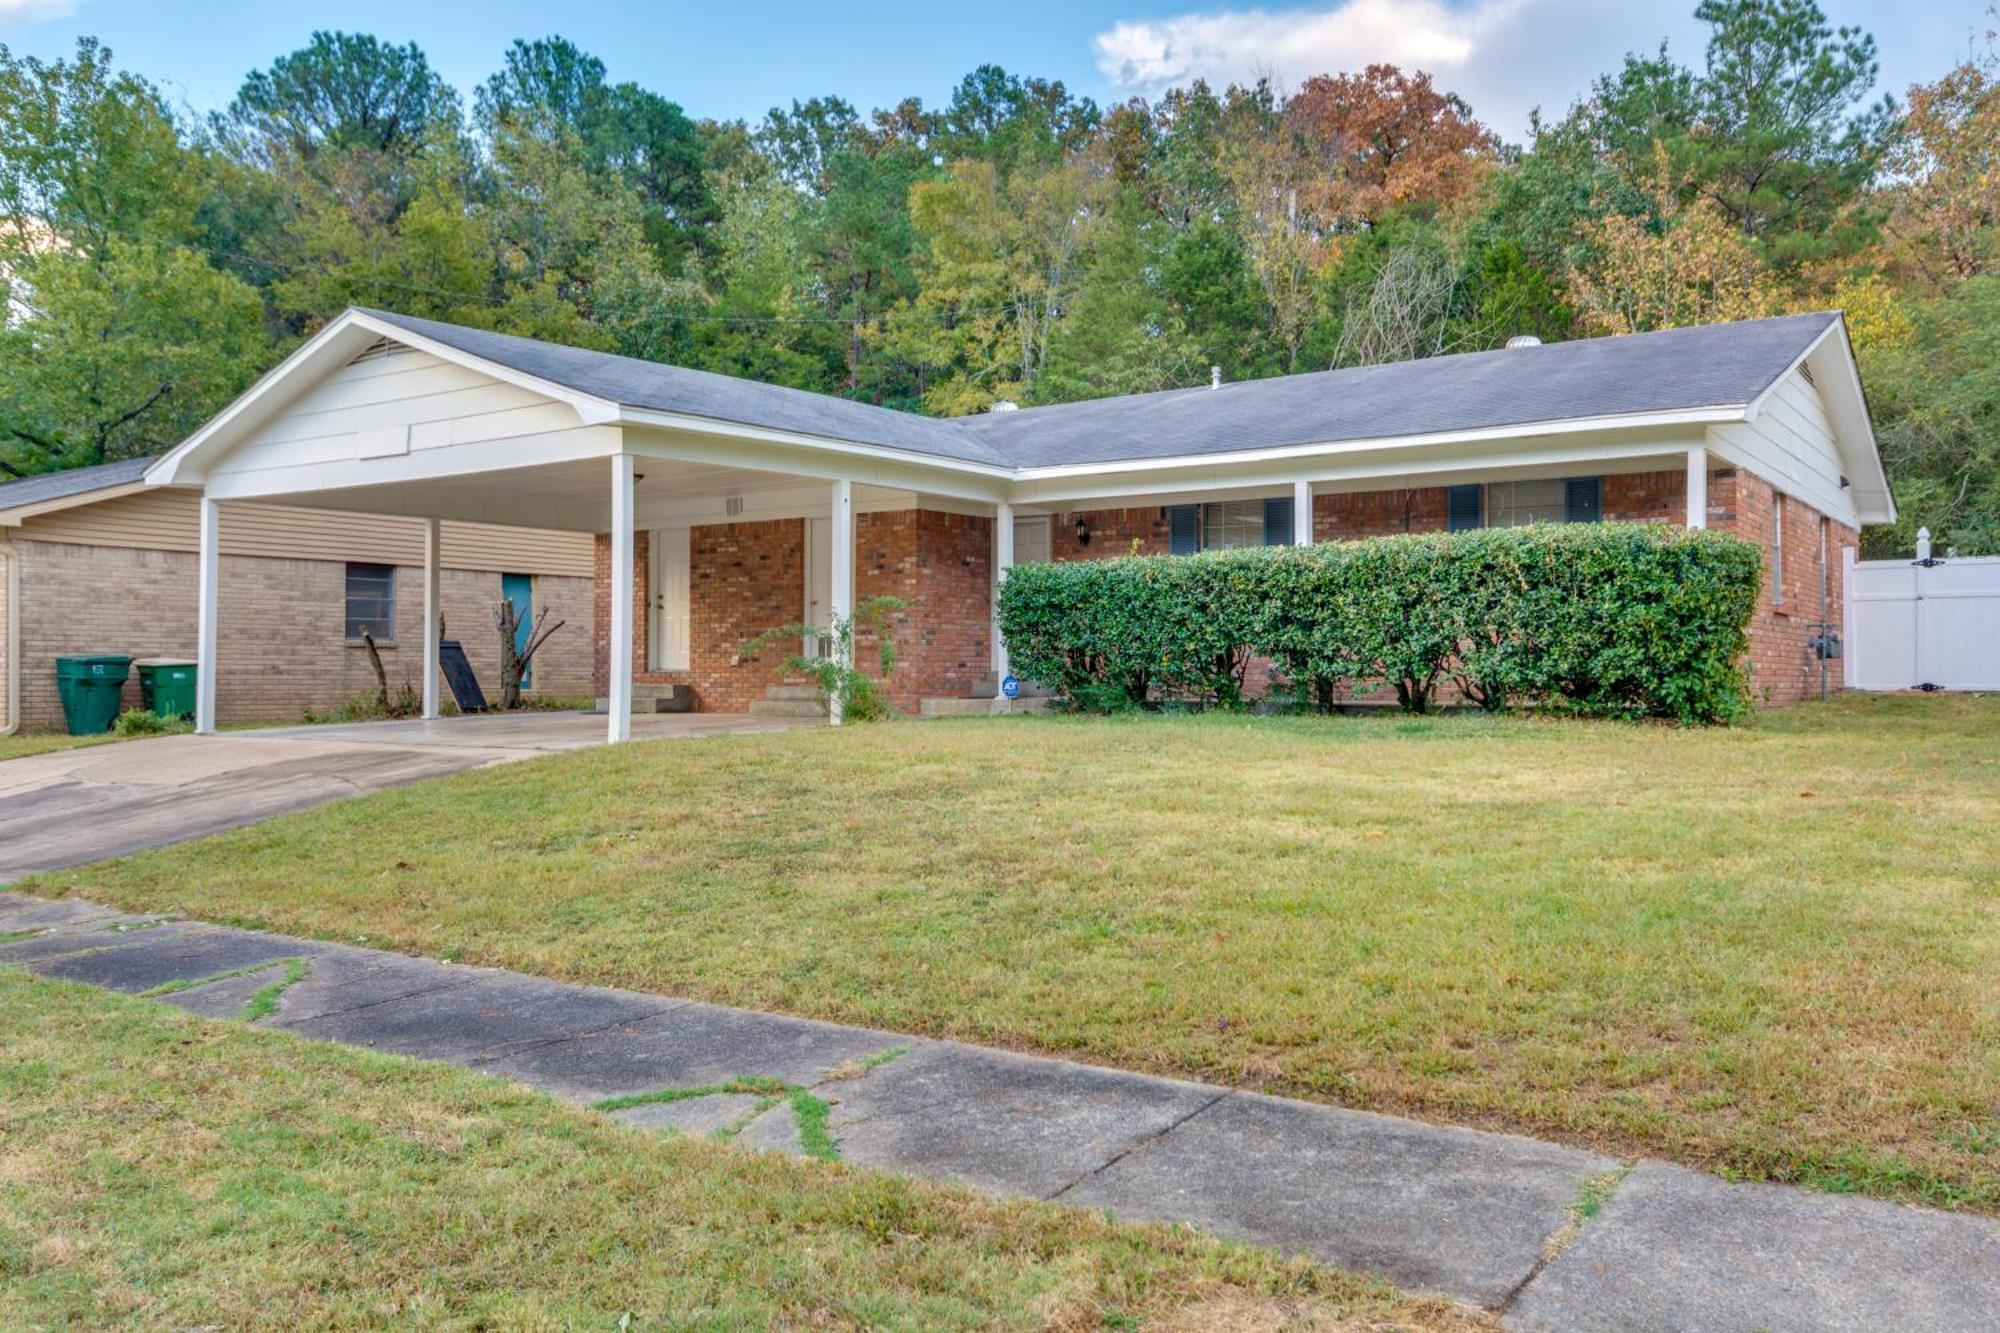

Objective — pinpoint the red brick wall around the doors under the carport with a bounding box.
[594,508,992,713]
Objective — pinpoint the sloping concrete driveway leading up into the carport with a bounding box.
[0,713,810,883]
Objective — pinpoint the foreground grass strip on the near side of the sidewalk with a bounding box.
[0,969,1492,1331]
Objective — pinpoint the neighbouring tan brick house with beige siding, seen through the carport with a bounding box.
[0,458,596,731]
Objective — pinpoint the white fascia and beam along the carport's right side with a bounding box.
[624,408,1014,502]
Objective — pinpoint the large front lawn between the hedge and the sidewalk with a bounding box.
[36,699,2000,1211]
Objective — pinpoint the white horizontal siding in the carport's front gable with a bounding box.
[210,348,602,488]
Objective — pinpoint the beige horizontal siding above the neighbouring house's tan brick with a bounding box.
[18,486,594,578]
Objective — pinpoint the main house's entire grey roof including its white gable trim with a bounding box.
[146,308,1894,522]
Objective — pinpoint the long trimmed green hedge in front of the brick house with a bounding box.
[1000,522,1762,723]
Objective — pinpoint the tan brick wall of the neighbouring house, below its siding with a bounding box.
[12,540,592,731]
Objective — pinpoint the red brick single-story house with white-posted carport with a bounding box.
[146,310,1894,739]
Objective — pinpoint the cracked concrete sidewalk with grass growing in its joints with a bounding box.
[0,880,2000,1333]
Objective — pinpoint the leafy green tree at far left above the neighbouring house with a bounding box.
[0,40,268,474]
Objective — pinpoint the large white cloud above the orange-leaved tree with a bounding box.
[1094,0,1700,140]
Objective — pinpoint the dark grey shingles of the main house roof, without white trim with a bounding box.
[368,310,1840,468]
